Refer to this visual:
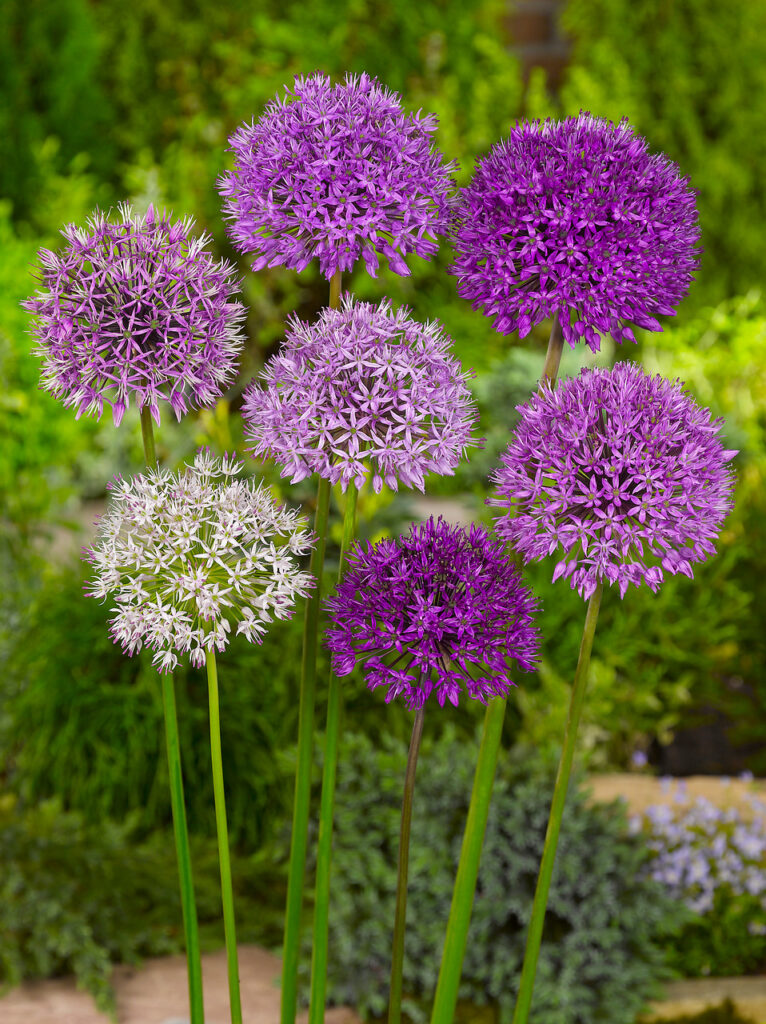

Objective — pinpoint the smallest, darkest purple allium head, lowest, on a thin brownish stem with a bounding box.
[327,518,540,710]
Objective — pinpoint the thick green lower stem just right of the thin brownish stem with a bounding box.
[431,697,508,1024]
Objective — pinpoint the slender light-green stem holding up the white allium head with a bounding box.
[205,648,242,1024]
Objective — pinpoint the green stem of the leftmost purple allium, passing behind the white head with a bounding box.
[141,406,205,1024]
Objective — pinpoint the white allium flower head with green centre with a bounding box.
[85,450,313,672]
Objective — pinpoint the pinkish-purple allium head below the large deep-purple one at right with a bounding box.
[488,362,736,598]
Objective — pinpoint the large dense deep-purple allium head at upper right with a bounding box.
[451,114,699,351]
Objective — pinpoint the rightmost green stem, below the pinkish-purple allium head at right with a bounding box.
[513,584,603,1024]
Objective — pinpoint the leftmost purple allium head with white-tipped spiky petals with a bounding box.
[23,204,245,425]
